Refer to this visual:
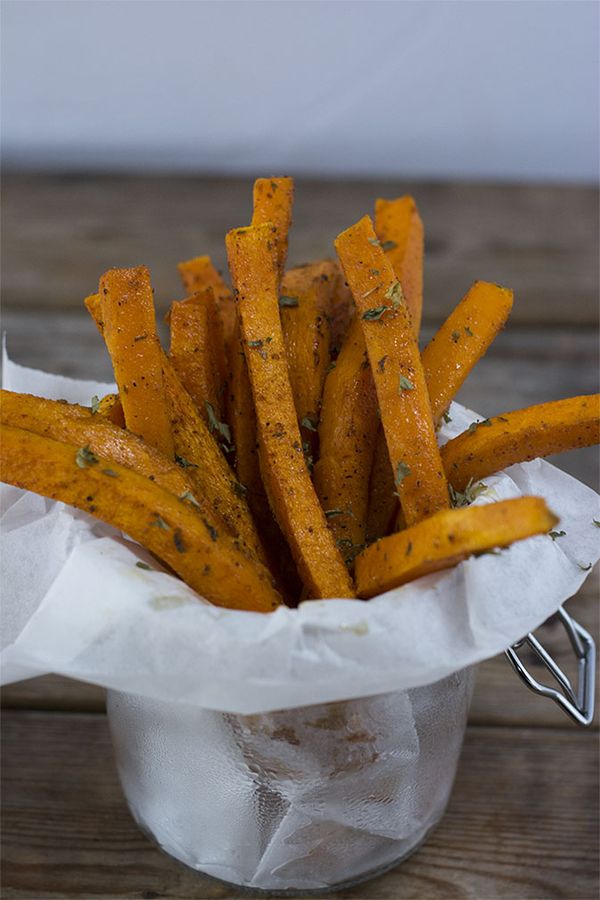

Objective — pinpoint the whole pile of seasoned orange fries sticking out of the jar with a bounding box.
[2,178,600,612]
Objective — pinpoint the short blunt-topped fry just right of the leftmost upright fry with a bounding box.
[169,287,224,428]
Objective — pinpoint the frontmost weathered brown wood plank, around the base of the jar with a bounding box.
[2,712,598,900]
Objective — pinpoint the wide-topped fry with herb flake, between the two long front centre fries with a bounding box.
[279,264,335,456]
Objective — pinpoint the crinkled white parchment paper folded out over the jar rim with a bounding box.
[0,356,600,713]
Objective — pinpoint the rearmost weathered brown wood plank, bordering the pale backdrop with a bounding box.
[2,174,598,325]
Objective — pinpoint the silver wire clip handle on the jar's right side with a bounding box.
[505,606,596,725]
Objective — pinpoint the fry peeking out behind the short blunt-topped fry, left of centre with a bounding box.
[177,256,235,400]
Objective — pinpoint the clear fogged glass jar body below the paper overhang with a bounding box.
[108,669,473,894]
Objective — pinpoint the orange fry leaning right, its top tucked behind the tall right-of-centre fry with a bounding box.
[313,318,376,563]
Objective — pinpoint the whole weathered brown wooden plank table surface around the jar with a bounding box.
[2,174,599,900]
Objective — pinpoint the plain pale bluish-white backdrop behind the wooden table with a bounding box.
[2,0,599,181]
